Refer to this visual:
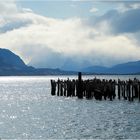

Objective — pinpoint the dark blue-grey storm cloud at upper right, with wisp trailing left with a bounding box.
[89,9,140,34]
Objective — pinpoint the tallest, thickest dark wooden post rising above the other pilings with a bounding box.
[77,72,83,99]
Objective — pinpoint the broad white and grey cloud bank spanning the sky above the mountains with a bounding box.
[0,0,140,69]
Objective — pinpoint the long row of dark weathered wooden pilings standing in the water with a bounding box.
[51,72,140,101]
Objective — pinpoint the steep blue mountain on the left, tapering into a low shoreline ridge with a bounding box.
[0,48,75,76]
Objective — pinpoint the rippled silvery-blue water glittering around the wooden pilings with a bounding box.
[0,76,140,139]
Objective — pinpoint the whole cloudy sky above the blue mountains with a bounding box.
[0,0,140,70]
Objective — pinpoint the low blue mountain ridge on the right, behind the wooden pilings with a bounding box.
[82,61,140,74]
